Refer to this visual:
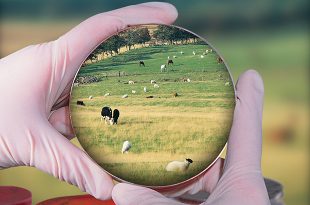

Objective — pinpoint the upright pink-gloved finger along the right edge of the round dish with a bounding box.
[225,70,264,170]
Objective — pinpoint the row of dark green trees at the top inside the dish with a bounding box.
[86,25,198,61]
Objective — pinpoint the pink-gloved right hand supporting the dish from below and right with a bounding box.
[112,70,270,205]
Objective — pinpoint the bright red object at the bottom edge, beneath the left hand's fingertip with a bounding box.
[37,195,115,205]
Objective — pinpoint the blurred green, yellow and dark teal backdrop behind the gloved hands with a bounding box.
[0,0,310,205]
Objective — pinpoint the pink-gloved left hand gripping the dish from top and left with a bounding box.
[0,2,177,199]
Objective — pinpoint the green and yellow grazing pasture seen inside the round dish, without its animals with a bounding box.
[71,45,234,186]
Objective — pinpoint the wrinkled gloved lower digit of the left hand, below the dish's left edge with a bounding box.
[29,120,114,200]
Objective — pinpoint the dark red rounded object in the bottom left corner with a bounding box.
[0,186,32,205]
